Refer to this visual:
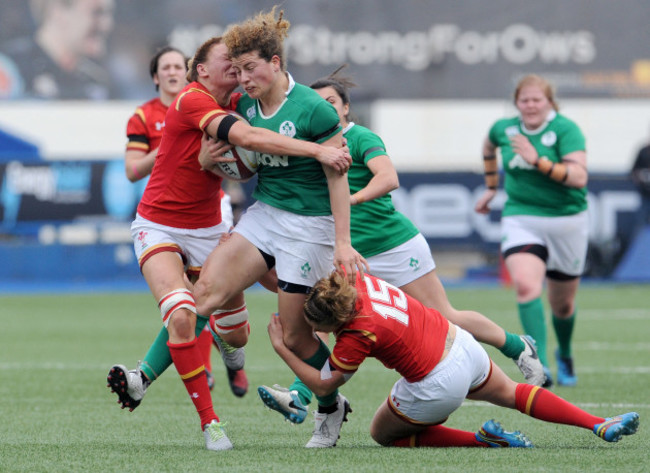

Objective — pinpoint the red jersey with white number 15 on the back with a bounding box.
[330,273,449,382]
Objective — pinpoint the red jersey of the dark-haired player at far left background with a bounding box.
[126,97,167,153]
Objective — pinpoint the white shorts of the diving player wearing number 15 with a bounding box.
[388,326,490,425]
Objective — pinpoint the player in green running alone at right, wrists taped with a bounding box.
[476,75,589,386]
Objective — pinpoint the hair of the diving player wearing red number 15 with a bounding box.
[304,271,357,326]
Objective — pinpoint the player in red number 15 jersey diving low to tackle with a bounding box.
[268,272,639,447]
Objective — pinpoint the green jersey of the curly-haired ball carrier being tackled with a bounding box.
[237,76,341,216]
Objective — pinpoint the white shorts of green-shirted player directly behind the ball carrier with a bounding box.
[366,233,436,287]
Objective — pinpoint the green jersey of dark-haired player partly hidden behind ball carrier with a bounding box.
[343,123,419,258]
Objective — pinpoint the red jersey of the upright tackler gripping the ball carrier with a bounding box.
[138,82,241,229]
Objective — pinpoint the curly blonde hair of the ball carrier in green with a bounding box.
[223,5,291,70]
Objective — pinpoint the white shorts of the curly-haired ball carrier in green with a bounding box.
[234,201,335,287]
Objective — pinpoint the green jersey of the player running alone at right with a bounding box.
[488,113,587,217]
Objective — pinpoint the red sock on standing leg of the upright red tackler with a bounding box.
[167,338,219,428]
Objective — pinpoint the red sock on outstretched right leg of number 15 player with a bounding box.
[515,384,605,430]
